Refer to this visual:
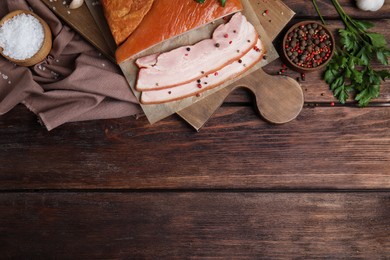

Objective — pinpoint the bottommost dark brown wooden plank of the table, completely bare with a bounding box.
[0,193,390,259]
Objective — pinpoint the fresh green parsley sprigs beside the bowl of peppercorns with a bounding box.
[313,0,390,107]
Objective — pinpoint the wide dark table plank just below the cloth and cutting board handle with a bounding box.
[0,106,390,190]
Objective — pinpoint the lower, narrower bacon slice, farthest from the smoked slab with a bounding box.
[141,39,265,104]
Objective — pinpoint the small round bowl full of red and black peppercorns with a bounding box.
[283,21,335,72]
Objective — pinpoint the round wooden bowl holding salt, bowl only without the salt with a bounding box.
[0,10,52,67]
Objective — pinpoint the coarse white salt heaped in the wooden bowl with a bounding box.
[0,14,45,60]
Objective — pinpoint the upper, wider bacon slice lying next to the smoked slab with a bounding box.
[135,13,258,91]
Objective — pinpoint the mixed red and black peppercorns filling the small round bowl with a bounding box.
[284,23,333,68]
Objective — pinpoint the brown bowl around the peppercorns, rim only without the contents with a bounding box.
[282,21,335,72]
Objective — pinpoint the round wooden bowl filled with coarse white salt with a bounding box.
[0,10,52,67]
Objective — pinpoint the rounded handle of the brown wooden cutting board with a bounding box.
[229,69,304,124]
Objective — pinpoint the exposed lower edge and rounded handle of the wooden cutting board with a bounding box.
[178,69,304,130]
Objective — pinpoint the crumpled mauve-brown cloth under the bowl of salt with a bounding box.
[0,0,142,130]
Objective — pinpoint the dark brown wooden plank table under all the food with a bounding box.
[0,0,390,259]
